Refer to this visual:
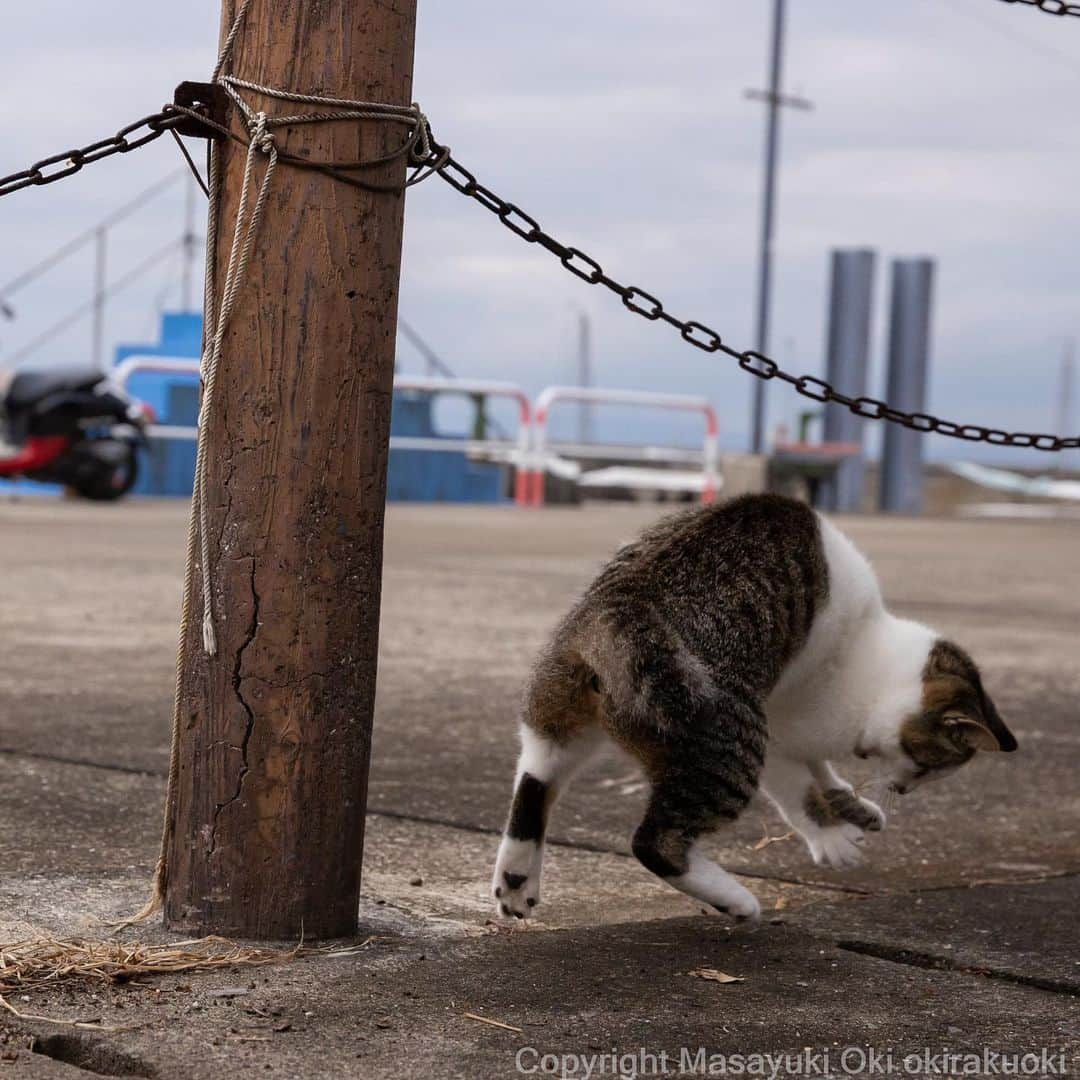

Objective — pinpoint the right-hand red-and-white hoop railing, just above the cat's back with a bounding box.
[527,387,719,507]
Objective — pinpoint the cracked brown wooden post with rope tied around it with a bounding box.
[165,0,416,939]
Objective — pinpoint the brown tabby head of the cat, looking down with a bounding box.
[892,639,1016,795]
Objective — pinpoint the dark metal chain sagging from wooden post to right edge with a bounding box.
[432,142,1080,450]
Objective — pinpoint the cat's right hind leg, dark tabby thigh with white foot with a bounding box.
[631,697,766,921]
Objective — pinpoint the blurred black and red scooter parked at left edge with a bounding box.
[0,368,153,501]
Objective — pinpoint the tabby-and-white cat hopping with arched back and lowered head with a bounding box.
[491,495,1016,920]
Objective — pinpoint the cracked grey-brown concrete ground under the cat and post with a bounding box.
[0,500,1080,1080]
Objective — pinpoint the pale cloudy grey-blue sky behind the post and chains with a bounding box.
[0,0,1080,465]
